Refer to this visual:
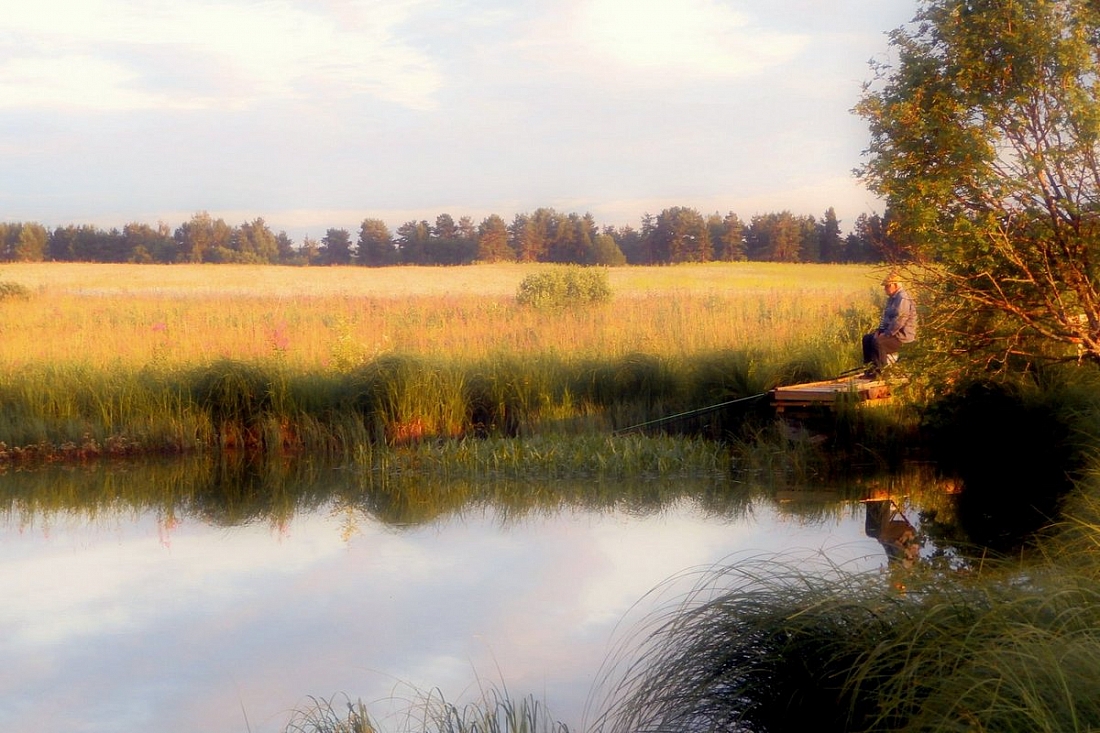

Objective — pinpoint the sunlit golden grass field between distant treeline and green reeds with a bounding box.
[0,263,879,374]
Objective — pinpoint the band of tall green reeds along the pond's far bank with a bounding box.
[0,343,862,452]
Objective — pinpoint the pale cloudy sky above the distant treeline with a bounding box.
[0,0,916,241]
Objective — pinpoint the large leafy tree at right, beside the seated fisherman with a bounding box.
[857,0,1100,364]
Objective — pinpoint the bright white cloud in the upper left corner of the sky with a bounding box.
[0,0,442,110]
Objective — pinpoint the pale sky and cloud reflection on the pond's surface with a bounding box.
[0,493,881,733]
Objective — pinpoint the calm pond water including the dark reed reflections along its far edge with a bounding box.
[0,466,946,733]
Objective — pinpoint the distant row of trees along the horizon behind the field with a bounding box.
[0,202,892,266]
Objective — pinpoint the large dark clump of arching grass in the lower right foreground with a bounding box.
[597,554,1100,733]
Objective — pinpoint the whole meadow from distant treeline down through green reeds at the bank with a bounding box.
[0,263,881,452]
